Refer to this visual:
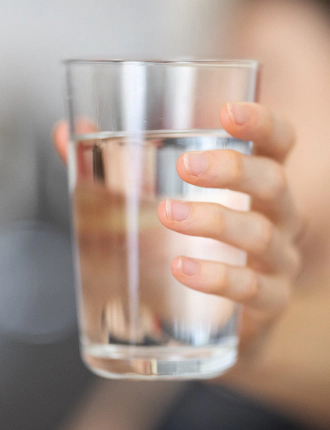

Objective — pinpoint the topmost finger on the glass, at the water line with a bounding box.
[220,103,295,161]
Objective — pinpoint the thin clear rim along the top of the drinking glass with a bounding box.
[62,58,260,69]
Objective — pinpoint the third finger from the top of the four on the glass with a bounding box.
[158,200,296,273]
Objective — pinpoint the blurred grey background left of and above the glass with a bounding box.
[0,0,235,430]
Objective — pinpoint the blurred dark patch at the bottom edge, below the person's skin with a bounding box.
[155,382,315,430]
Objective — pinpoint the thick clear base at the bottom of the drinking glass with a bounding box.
[82,337,237,380]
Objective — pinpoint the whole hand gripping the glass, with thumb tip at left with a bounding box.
[54,103,302,354]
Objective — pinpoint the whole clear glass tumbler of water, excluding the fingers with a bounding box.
[65,60,258,379]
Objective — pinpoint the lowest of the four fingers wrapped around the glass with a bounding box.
[171,257,290,314]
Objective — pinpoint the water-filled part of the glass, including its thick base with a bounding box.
[69,131,250,379]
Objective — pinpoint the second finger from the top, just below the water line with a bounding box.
[177,150,297,230]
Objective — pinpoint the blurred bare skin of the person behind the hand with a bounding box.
[217,0,330,429]
